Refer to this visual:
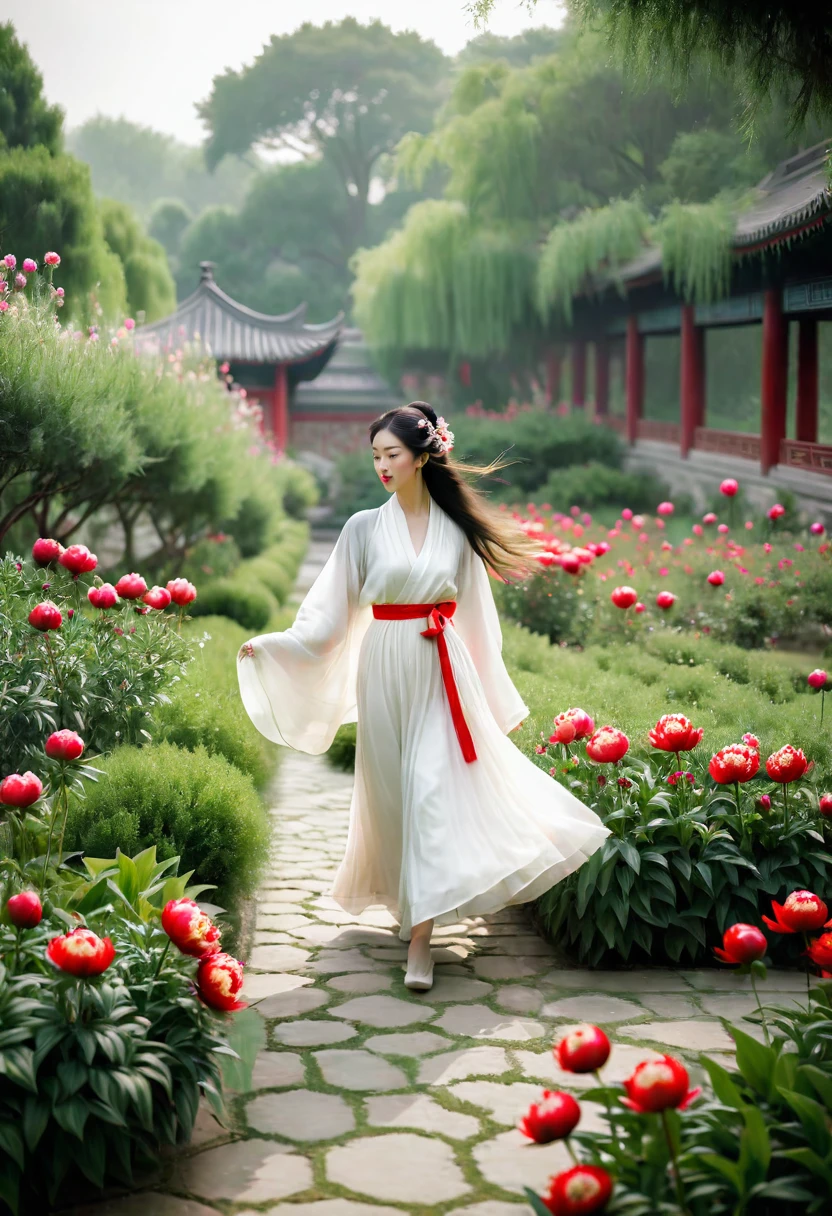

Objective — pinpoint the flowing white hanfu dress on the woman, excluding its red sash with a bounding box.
[237,494,609,941]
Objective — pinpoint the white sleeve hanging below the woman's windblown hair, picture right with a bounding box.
[452,537,530,734]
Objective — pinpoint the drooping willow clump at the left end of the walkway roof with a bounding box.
[536,198,651,322]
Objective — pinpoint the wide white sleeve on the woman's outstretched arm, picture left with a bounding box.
[237,513,372,755]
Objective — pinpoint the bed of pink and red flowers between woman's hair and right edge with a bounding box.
[499,493,832,647]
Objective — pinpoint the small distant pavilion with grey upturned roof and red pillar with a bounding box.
[135,261,343,451]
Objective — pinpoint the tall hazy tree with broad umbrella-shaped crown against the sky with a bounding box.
[198,17,448,248]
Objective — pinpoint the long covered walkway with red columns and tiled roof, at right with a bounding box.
[550,142,832,513]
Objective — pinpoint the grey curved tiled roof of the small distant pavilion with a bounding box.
[135,261,343,364]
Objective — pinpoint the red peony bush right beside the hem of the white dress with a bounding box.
[535,714,832,966]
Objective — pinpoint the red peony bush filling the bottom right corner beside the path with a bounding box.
[518,914,832,1216]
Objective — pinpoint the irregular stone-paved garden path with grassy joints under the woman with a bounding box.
[66,527,805,1216]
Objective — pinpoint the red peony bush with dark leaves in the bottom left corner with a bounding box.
[0,849,264,1214]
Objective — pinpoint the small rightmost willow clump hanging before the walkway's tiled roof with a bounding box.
[656,198,735,304]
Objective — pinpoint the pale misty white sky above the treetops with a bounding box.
[8,0,562,143]
